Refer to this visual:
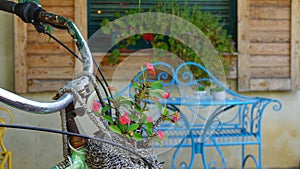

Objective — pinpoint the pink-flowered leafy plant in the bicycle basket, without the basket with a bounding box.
[92,63,180,143]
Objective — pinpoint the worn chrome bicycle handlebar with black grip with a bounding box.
[0,0,93,114]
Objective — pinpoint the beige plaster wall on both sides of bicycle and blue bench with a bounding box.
[0,12,300,169]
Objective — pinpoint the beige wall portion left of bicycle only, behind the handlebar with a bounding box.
[0,12,62,169]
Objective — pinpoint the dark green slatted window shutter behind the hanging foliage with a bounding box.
[88,0,236,44]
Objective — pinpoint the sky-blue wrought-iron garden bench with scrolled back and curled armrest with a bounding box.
[120,62,281,169]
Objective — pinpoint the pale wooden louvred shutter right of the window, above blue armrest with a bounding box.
[238,0,300,91]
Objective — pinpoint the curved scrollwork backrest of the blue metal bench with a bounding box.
[118,62,247,99]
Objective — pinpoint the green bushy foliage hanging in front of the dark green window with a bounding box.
[101,0,235,77]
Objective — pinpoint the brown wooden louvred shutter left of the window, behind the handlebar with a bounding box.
[14,0,86,93]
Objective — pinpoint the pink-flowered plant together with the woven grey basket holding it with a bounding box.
[86,63,180,168]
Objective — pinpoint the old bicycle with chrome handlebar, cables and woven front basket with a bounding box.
[0,0,161,169]
